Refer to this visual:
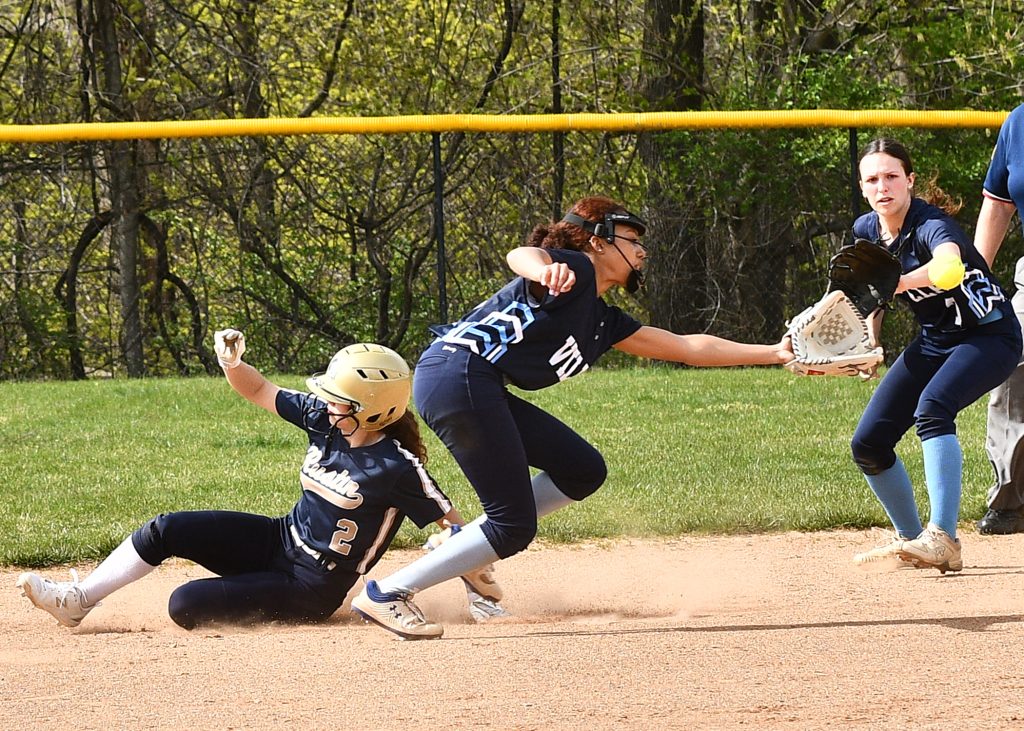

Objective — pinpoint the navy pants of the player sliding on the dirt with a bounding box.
[132,510,358,630]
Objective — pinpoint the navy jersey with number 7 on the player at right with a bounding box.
[853,193,1007,334]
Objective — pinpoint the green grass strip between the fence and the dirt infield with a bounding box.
[0,367,991,566]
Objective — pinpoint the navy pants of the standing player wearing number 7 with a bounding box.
[851,316,1021,475]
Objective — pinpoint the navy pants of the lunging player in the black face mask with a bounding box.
[413,343,607,558]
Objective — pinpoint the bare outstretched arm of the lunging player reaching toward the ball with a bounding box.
[614,326,794,367]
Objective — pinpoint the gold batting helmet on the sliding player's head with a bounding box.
[306,343,412,436]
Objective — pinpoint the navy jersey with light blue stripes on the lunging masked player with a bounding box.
[431,249,641,391]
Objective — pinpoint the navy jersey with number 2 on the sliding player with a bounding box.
[275,389,452,573]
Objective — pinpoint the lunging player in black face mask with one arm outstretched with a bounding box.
[352,197,793,638]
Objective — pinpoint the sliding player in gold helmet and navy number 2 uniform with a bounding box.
[17,330,503,630]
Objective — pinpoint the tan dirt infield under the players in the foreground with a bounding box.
[0,531,1024,731]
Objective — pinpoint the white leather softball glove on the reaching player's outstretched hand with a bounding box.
[785,291,885,379]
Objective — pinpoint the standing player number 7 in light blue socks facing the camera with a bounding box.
[852,139,1021,573]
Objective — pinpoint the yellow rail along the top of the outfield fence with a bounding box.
[0,110,1009,142]
